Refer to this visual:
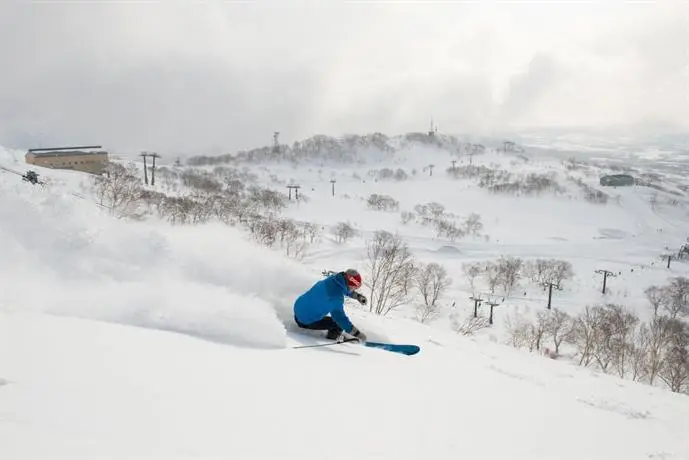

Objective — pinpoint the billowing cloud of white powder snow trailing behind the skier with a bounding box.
[0,161,310,347]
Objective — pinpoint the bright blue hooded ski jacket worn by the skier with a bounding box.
[294,273,354,332]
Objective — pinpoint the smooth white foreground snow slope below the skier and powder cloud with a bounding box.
[0,313,689,460]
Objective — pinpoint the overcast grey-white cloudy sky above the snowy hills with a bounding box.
[0,0,689,153]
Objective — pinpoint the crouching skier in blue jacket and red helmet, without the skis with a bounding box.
[294,268,366,342]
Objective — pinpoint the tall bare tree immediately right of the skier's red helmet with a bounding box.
[367,230,414,315]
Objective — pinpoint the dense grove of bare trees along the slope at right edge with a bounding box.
[498,278,689,392]
